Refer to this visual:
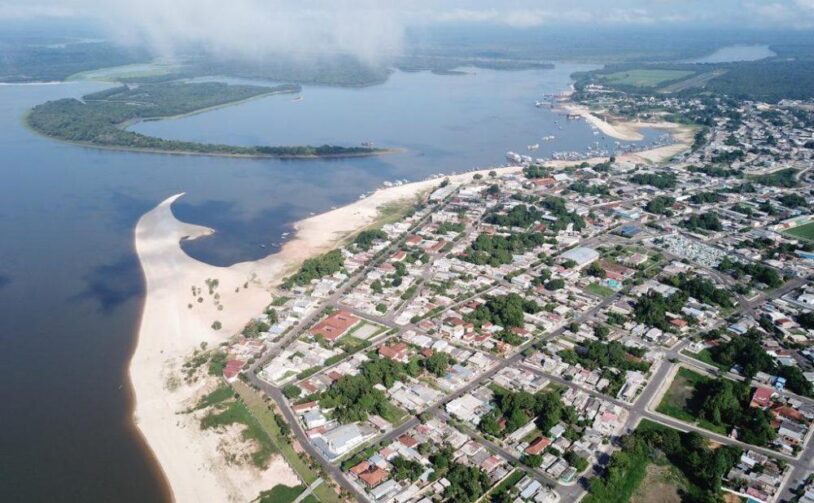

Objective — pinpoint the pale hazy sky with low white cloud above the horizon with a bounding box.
[0,0,814,61]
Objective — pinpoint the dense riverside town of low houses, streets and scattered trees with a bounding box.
[193,85,814,503]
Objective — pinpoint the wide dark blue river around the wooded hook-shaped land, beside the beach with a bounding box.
[0,67,656,502]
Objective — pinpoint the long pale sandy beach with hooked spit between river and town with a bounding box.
[129,129,687,502]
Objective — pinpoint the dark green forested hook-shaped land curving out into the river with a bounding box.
[26,82,387,159]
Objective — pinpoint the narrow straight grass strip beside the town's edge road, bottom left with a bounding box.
[233,381,342,503]
